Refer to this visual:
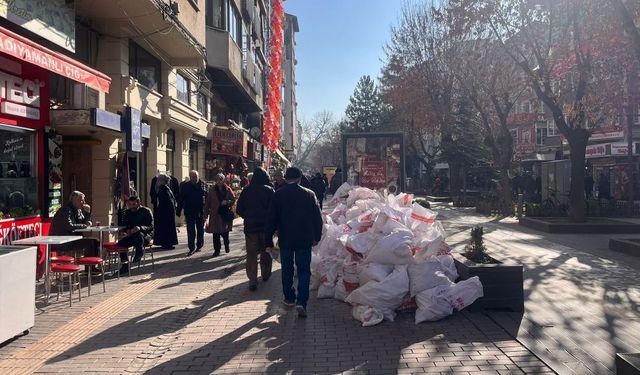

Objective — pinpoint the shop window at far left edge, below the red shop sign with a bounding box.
[0,125,39,219]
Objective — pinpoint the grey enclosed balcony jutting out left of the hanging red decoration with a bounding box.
[207,28,262,113]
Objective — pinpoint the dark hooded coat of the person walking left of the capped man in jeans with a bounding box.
[236,172,275,234]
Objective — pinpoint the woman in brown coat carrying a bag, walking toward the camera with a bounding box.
[205,173,235,257]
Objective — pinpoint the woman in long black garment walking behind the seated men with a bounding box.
[153,174,178,250]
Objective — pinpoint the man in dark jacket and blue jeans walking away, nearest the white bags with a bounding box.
[265,168,322,317]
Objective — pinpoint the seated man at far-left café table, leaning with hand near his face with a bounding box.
[49,191,98,257]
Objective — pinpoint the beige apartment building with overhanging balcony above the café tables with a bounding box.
[50,0,206,223]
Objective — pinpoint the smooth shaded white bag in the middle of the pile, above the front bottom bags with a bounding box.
[364,230,413,264]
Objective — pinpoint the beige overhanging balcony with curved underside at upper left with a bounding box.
[75,0,204,67]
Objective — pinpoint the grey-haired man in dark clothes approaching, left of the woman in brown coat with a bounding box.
[178,171,208,256]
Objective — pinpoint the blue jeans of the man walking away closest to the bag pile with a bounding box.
[280,247,311,308]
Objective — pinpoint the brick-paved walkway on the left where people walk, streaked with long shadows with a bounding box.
[0,219,552,374]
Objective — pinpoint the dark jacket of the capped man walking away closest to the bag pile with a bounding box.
[265,184,322,249]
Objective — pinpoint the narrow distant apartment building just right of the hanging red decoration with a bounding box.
[280,13,300,162]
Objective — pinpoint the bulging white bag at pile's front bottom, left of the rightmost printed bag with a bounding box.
[345,266,409,320]
